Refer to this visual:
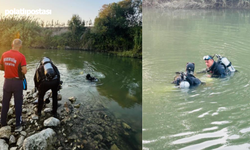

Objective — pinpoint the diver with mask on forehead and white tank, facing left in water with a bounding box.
[203,54,236,78]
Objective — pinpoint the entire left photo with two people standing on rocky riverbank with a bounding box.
[0,0,142,150]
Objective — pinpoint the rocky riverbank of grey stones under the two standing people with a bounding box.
[0,91,140,150]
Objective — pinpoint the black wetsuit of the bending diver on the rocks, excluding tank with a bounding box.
[34,63,60,115]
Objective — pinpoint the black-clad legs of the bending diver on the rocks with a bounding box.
[37,80,59,114]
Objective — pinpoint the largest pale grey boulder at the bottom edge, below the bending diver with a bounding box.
[23,128,56,150]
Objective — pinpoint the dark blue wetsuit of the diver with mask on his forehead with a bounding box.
[208,62,227,78]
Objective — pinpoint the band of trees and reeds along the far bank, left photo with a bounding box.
[0,0,142,58]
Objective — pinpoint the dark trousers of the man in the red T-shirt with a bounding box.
[1,79,23,126]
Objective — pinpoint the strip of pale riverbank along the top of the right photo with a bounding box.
[143,0,250,9]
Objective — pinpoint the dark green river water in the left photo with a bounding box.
[0,48,142,149]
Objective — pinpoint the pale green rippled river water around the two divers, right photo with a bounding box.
[142,8,250,150]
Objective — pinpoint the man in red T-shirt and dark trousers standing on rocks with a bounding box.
[0,39,27,131]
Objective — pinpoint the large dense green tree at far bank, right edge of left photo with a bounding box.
[93,0,142,51]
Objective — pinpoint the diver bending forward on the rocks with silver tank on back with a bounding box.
[34,57,62,117]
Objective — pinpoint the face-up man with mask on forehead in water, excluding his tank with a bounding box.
[203,55,227,78]
